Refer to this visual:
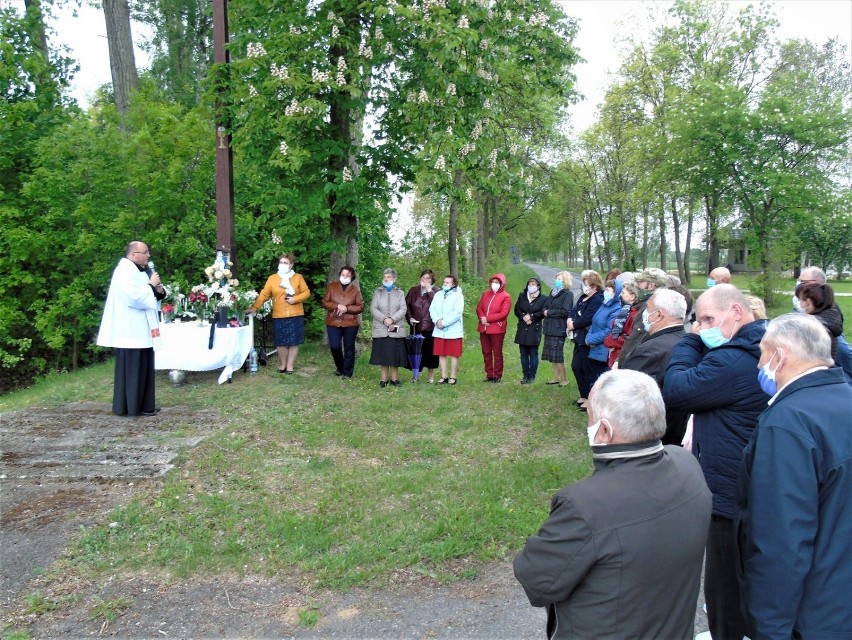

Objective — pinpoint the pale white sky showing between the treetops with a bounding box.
[38,0,852,131]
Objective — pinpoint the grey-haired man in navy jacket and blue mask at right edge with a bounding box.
[735,314,852,639]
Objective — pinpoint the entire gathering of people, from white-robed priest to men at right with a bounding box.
[98,241,852,640]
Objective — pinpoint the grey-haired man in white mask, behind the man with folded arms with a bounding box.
[620,289,689,445]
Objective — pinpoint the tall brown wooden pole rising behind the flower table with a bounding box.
[213,0,237,265]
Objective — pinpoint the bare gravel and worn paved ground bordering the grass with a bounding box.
[0,403,706,638]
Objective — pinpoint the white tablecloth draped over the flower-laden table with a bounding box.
[154,316,254,384]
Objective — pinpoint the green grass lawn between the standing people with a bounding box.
[0,266,591,588]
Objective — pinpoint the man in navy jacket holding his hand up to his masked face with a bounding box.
[663,284,769,640]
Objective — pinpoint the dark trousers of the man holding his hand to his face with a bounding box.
[704,515,754,640]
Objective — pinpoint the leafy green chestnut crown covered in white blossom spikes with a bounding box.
[229,0,578,274]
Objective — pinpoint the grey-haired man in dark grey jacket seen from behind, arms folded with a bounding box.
[514,371,711,640]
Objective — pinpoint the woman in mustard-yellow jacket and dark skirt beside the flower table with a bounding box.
[249,253,311,373]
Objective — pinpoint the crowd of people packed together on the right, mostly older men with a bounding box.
[514,267,852,640]
